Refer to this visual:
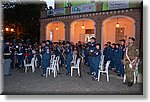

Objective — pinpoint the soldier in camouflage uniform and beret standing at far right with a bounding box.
[123,37,139,87]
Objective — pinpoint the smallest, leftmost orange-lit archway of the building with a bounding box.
[46,21,65,42]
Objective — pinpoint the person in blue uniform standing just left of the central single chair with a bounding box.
[65,42,73,76]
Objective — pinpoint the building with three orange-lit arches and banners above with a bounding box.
[40,0,143,56]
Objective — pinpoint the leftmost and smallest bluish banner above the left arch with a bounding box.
[47,8,65,16]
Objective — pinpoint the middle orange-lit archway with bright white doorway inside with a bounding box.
[70,19,95,43]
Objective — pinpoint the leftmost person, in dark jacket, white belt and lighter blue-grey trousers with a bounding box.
[3,41,11,76]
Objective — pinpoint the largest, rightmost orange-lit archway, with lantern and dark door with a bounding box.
[101,16,135,49]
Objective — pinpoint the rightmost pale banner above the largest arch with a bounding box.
[108,0,129,10]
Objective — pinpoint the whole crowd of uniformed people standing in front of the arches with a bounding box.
[3,37,139,86]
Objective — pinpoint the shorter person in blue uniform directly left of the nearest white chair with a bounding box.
[93,44,101,81]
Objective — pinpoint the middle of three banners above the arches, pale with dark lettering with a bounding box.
[71,3,95,14]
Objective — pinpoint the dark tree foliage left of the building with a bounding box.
[2,1,47,42]
